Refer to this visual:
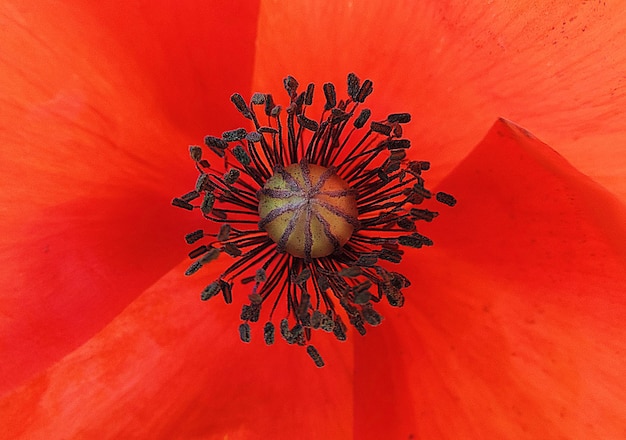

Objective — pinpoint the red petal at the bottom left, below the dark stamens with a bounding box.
[0,257,353,439]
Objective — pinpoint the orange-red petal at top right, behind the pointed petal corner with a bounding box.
[255,0,626,200]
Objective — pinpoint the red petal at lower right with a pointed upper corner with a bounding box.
[355,120,626,439]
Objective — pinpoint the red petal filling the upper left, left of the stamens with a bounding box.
[0,2,256,392]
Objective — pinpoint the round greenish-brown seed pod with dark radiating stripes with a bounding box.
[257,161,358,261]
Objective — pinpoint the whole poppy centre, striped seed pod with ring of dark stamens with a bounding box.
[172,74,456,367]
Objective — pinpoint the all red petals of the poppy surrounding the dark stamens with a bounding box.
[0,0,626,439]
